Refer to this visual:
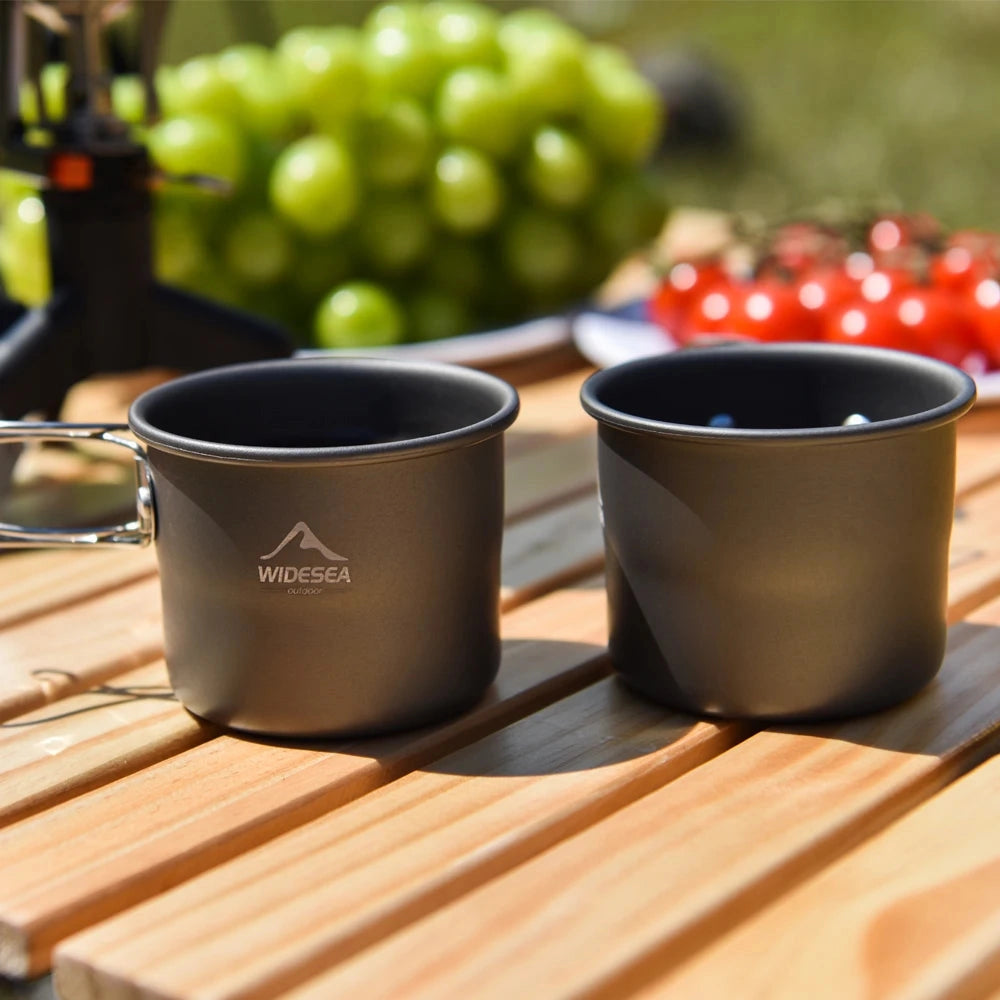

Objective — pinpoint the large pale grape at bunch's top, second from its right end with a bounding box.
[497,10,586,115]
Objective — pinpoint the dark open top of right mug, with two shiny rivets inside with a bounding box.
[583,345,975,434]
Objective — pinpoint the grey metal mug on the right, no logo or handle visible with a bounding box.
[581,344,975,720]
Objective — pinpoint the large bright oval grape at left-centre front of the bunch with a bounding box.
[270,135,359,237]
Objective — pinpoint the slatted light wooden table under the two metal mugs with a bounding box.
[0,354,1000,1000]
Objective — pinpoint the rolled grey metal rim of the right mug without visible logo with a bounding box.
[580,342,976,444]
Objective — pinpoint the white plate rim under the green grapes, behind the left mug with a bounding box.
[295,316,573,365]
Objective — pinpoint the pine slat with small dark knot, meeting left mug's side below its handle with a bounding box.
[0,576,163,719]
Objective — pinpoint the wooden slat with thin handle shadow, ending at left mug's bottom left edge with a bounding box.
[0,661,215,826]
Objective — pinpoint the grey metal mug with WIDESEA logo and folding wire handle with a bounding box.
[0,359,518,736]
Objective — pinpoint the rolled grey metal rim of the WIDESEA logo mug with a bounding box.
[128,357,520,466]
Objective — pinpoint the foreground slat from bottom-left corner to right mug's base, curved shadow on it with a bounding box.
[50,679,746,1000]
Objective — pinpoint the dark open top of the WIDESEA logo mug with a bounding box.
[129,359,517,460]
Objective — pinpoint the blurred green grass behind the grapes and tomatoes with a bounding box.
[163,0,1000,228]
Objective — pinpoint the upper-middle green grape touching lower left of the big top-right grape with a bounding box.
[435,66,520,158]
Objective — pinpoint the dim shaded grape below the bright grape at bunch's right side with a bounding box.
[501,208,581,292]
